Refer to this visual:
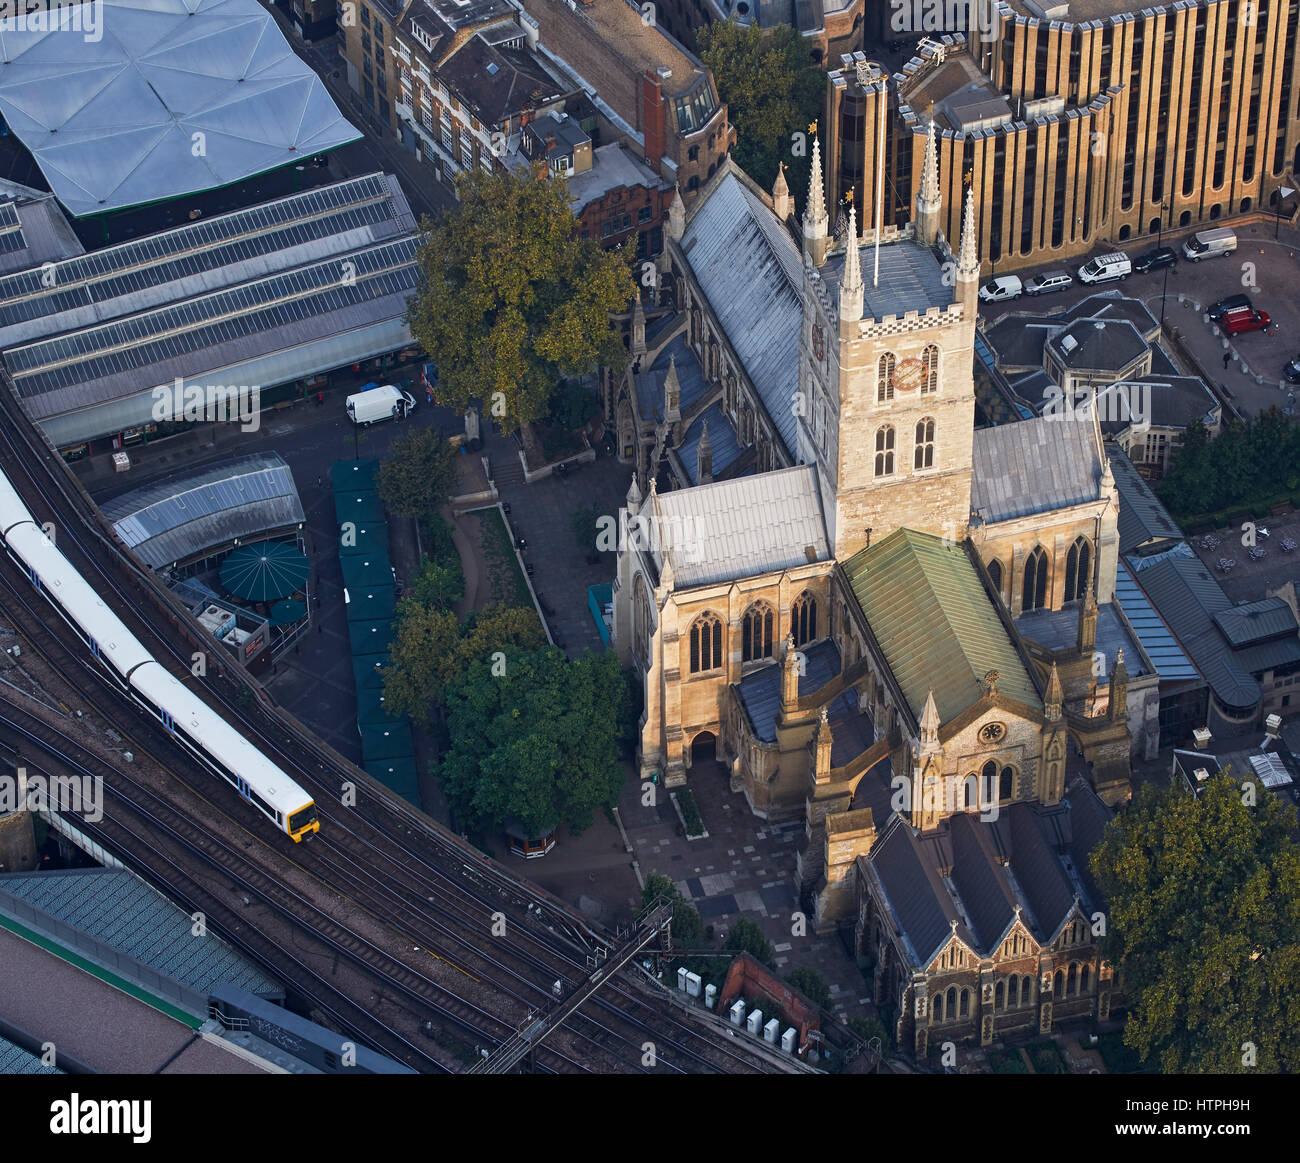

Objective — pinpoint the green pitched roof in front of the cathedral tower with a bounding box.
[844,529,1043,722]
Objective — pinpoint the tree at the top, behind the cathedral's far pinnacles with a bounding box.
[696,19,826,190]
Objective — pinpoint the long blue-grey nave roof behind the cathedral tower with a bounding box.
[681,168,803,456]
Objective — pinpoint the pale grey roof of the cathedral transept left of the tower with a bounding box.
[642,465,831,589]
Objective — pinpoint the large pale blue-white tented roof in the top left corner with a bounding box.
[0,0,360,217]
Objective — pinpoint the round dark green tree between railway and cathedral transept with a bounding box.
[436,647,624,836]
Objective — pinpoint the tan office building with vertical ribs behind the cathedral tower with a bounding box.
[828,0,1300,272]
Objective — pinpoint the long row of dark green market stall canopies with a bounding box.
[330,459,420,807]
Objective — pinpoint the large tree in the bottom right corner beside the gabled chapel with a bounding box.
[1092,772,1300,1073]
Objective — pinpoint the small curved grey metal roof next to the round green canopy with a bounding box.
[101,452,307,569]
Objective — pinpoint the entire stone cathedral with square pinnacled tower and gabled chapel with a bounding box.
[605,129,1133,1055]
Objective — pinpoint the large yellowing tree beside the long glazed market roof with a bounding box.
[407,170,634,433]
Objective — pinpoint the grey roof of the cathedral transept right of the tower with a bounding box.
[971,416,1102,524]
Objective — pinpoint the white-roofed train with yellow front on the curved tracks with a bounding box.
[0,472,320,843]
